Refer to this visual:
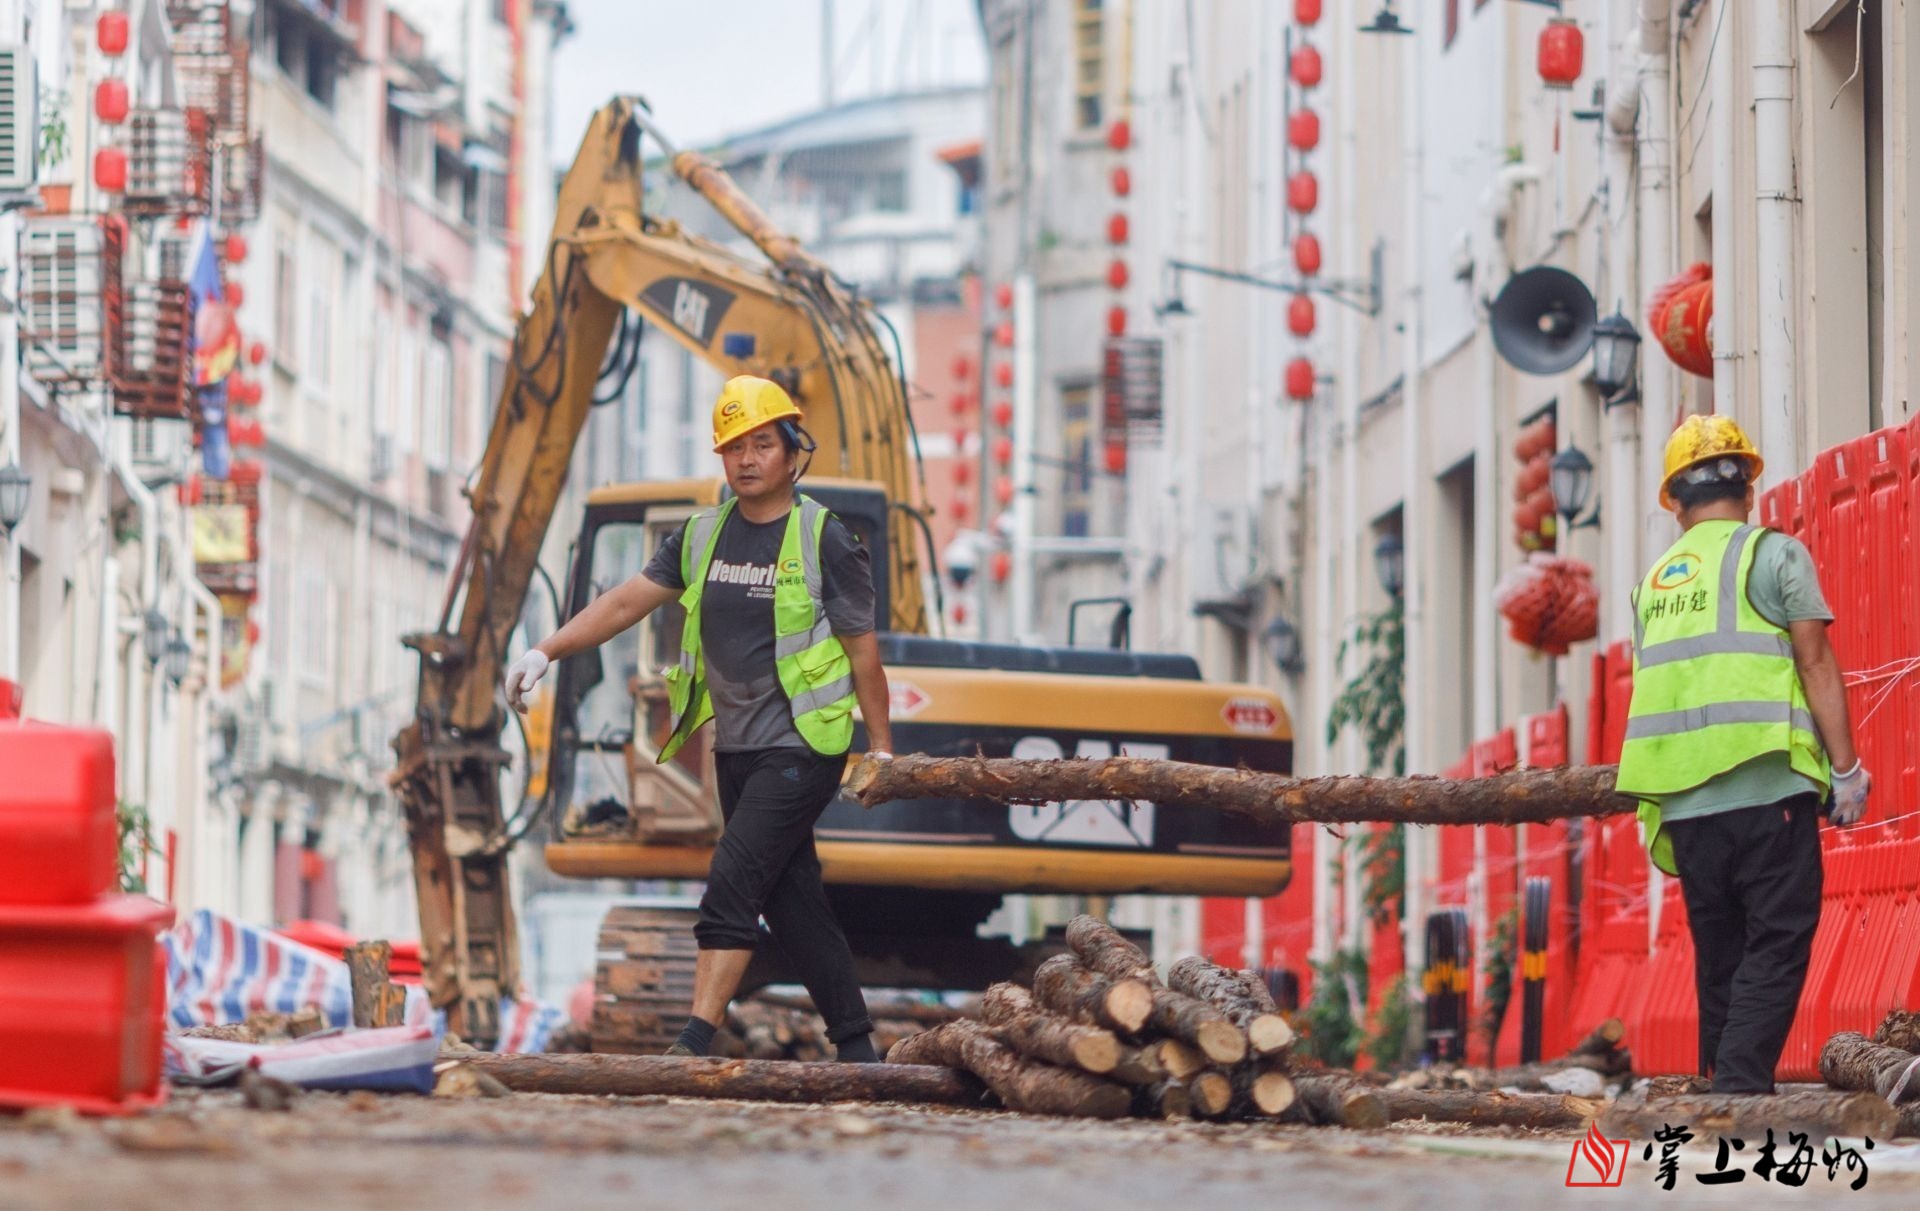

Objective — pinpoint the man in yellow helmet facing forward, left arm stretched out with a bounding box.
[507,374,893,1063]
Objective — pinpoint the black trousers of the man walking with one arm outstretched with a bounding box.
[693,748,874,1042]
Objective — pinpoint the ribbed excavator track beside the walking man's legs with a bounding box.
[588,906,699,1056]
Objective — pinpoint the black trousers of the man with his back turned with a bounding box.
[1667,795,1822,1094]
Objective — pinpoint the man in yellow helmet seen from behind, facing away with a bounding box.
[1619,416,1872,1094]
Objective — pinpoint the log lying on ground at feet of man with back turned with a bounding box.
[1599,1090,1899,1140]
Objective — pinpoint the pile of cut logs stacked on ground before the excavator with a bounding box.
[887,915,1296,1119]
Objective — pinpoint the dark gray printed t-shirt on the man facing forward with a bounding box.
[641,509,874,752]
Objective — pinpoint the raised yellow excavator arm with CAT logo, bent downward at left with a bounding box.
[392,98,925,1046]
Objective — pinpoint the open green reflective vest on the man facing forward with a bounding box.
[659,495,856,762]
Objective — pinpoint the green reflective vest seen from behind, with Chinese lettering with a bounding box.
[1617,520,1830,875]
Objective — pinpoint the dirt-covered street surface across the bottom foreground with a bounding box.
[0,1092,1920,1211]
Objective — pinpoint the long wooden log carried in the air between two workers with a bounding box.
[847,756,1636,825]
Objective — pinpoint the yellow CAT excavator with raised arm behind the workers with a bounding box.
[394,98,1292,1052]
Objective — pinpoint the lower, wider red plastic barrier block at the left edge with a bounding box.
[0,896,173,1115]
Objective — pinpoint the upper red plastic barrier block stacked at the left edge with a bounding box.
[0,713,119,904]
